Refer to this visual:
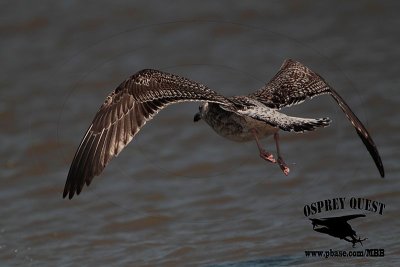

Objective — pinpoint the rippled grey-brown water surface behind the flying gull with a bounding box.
[0,1,400,266]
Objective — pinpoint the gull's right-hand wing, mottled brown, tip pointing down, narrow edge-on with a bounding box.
[249,59,385,177]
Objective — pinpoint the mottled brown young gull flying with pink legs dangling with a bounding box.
[63,59,385,199]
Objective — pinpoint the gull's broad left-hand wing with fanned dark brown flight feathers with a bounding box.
[63,69,230,199]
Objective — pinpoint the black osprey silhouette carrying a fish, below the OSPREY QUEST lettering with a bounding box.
[310,214,367,248]
